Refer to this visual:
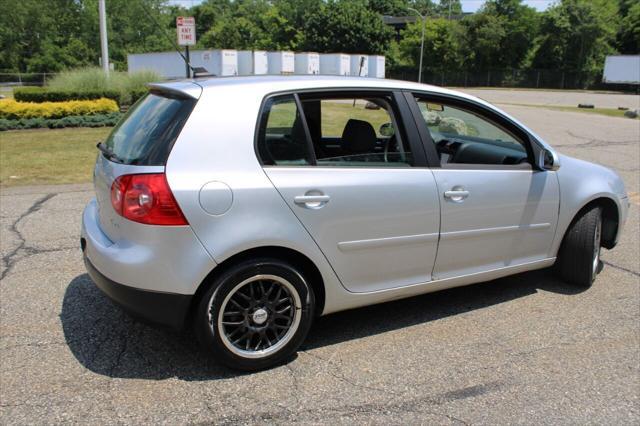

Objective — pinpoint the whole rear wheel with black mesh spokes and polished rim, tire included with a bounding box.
[195,259,315,371]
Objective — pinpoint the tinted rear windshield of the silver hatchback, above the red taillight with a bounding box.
[106,93,196,166]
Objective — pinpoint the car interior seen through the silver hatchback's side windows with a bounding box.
[258,96,528,167]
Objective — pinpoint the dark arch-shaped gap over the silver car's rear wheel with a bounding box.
[189,246,325,321]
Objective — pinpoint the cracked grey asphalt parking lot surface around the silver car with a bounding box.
[0,95,640,424]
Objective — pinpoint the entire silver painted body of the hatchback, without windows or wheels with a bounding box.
[82,76,627,314]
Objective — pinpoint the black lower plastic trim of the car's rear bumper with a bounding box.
[83,255,193,331]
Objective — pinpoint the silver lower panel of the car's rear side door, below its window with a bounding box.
[264,167,440,293]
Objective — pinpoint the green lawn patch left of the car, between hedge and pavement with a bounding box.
[0,127,111,187]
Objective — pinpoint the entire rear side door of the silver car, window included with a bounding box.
[258,92,440,292]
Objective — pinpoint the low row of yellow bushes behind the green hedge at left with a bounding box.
[0,98,120,120]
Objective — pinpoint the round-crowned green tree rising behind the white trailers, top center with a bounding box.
[301,0,393,54]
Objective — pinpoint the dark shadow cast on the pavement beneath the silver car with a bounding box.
[60,271,580,381]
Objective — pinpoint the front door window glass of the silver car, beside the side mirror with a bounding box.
[416,98,528,166]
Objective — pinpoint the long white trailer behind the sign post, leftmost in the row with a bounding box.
[127,49,238,79]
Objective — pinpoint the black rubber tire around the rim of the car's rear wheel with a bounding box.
[195,259,315,371]
